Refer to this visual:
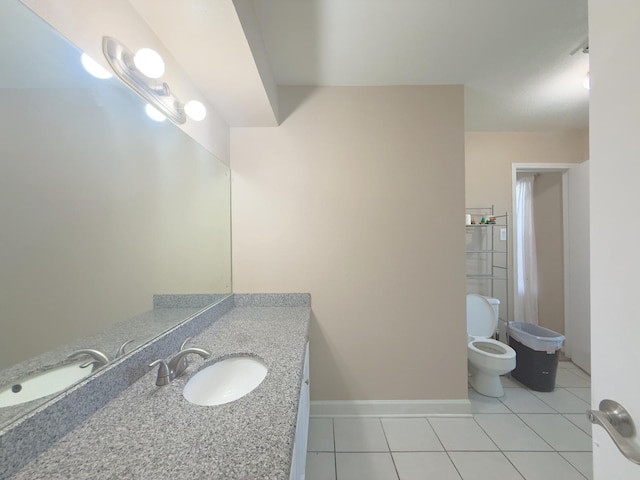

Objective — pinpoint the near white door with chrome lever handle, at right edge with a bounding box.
[589,0,640,480]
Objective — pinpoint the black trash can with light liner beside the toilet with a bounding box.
[509,322,564,392]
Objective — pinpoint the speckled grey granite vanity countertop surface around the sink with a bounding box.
[11,307,311,480]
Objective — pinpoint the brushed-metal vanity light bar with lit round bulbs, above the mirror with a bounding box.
[102,37,207,125]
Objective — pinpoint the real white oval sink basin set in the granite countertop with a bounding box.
[182,356,267,406]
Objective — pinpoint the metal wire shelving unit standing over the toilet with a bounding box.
[465,205,510,323]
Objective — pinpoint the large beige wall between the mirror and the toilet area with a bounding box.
[231,86,467,400]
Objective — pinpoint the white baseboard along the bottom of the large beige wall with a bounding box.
[311,399,471,417]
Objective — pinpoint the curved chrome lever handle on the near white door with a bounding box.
[587,399,640,465]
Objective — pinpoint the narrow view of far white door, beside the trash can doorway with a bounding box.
[565,161,591,372]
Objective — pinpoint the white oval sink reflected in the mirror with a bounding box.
[0,358,92,408]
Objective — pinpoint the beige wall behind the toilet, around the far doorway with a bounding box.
[465,130,589,319]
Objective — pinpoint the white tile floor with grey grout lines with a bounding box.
[306,362,593,480]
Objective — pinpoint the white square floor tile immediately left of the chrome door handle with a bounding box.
[519,414,591,452]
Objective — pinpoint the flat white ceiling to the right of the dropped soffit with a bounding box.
[252,0,589,131]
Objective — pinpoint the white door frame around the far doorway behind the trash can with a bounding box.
[511,163,578,357]
